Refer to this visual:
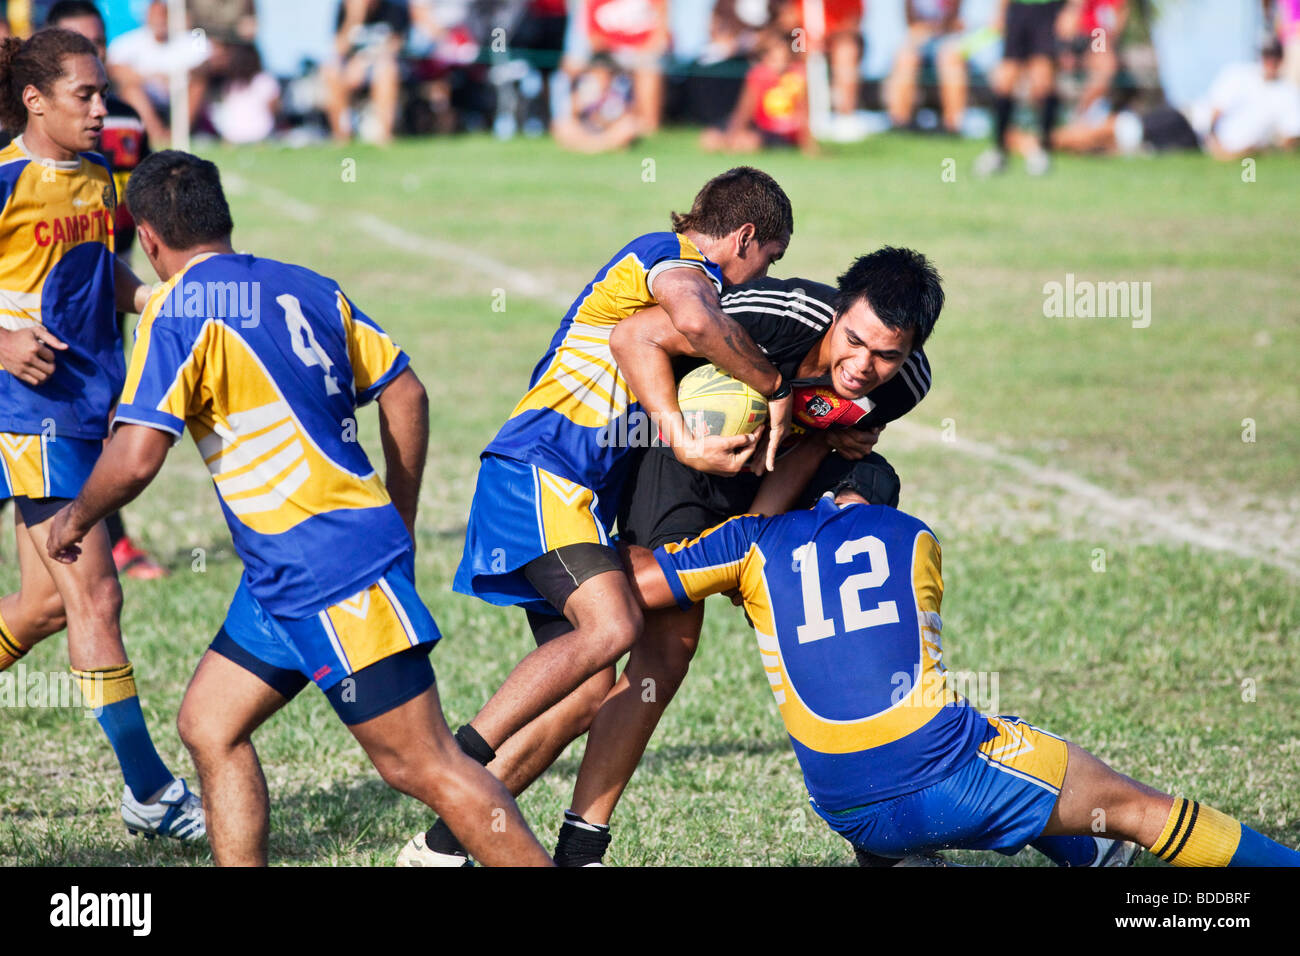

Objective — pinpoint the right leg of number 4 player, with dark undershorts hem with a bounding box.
[343,658,551,866]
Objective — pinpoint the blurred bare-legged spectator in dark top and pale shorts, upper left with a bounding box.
[321,0,411,146]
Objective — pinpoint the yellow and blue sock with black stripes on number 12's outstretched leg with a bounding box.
[1151,797,1300,866]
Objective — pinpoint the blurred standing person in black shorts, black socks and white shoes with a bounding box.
[975,0,1065,176]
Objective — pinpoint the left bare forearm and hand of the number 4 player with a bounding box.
[46,425,172,564]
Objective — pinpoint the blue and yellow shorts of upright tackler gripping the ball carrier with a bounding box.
[452,455,615,614]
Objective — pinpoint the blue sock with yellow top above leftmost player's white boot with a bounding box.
[73,663,173,803]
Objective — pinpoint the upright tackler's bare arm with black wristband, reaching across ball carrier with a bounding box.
[653,268,794,471]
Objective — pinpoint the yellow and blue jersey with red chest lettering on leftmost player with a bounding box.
[0,137,125,438]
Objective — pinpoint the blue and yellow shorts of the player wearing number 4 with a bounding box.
[212,551,442,715]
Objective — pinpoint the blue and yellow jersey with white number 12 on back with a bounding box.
[655,498,988,812]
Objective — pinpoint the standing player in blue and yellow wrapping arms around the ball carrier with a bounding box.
[403,166,794,865]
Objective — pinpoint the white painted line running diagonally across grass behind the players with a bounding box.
[222,173,1300,576]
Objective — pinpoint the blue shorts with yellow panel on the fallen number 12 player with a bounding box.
[813,717,1066,857]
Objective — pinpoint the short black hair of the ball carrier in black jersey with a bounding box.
[835,246,944,351]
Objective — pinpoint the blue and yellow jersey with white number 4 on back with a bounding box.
[114,255,411,618]
